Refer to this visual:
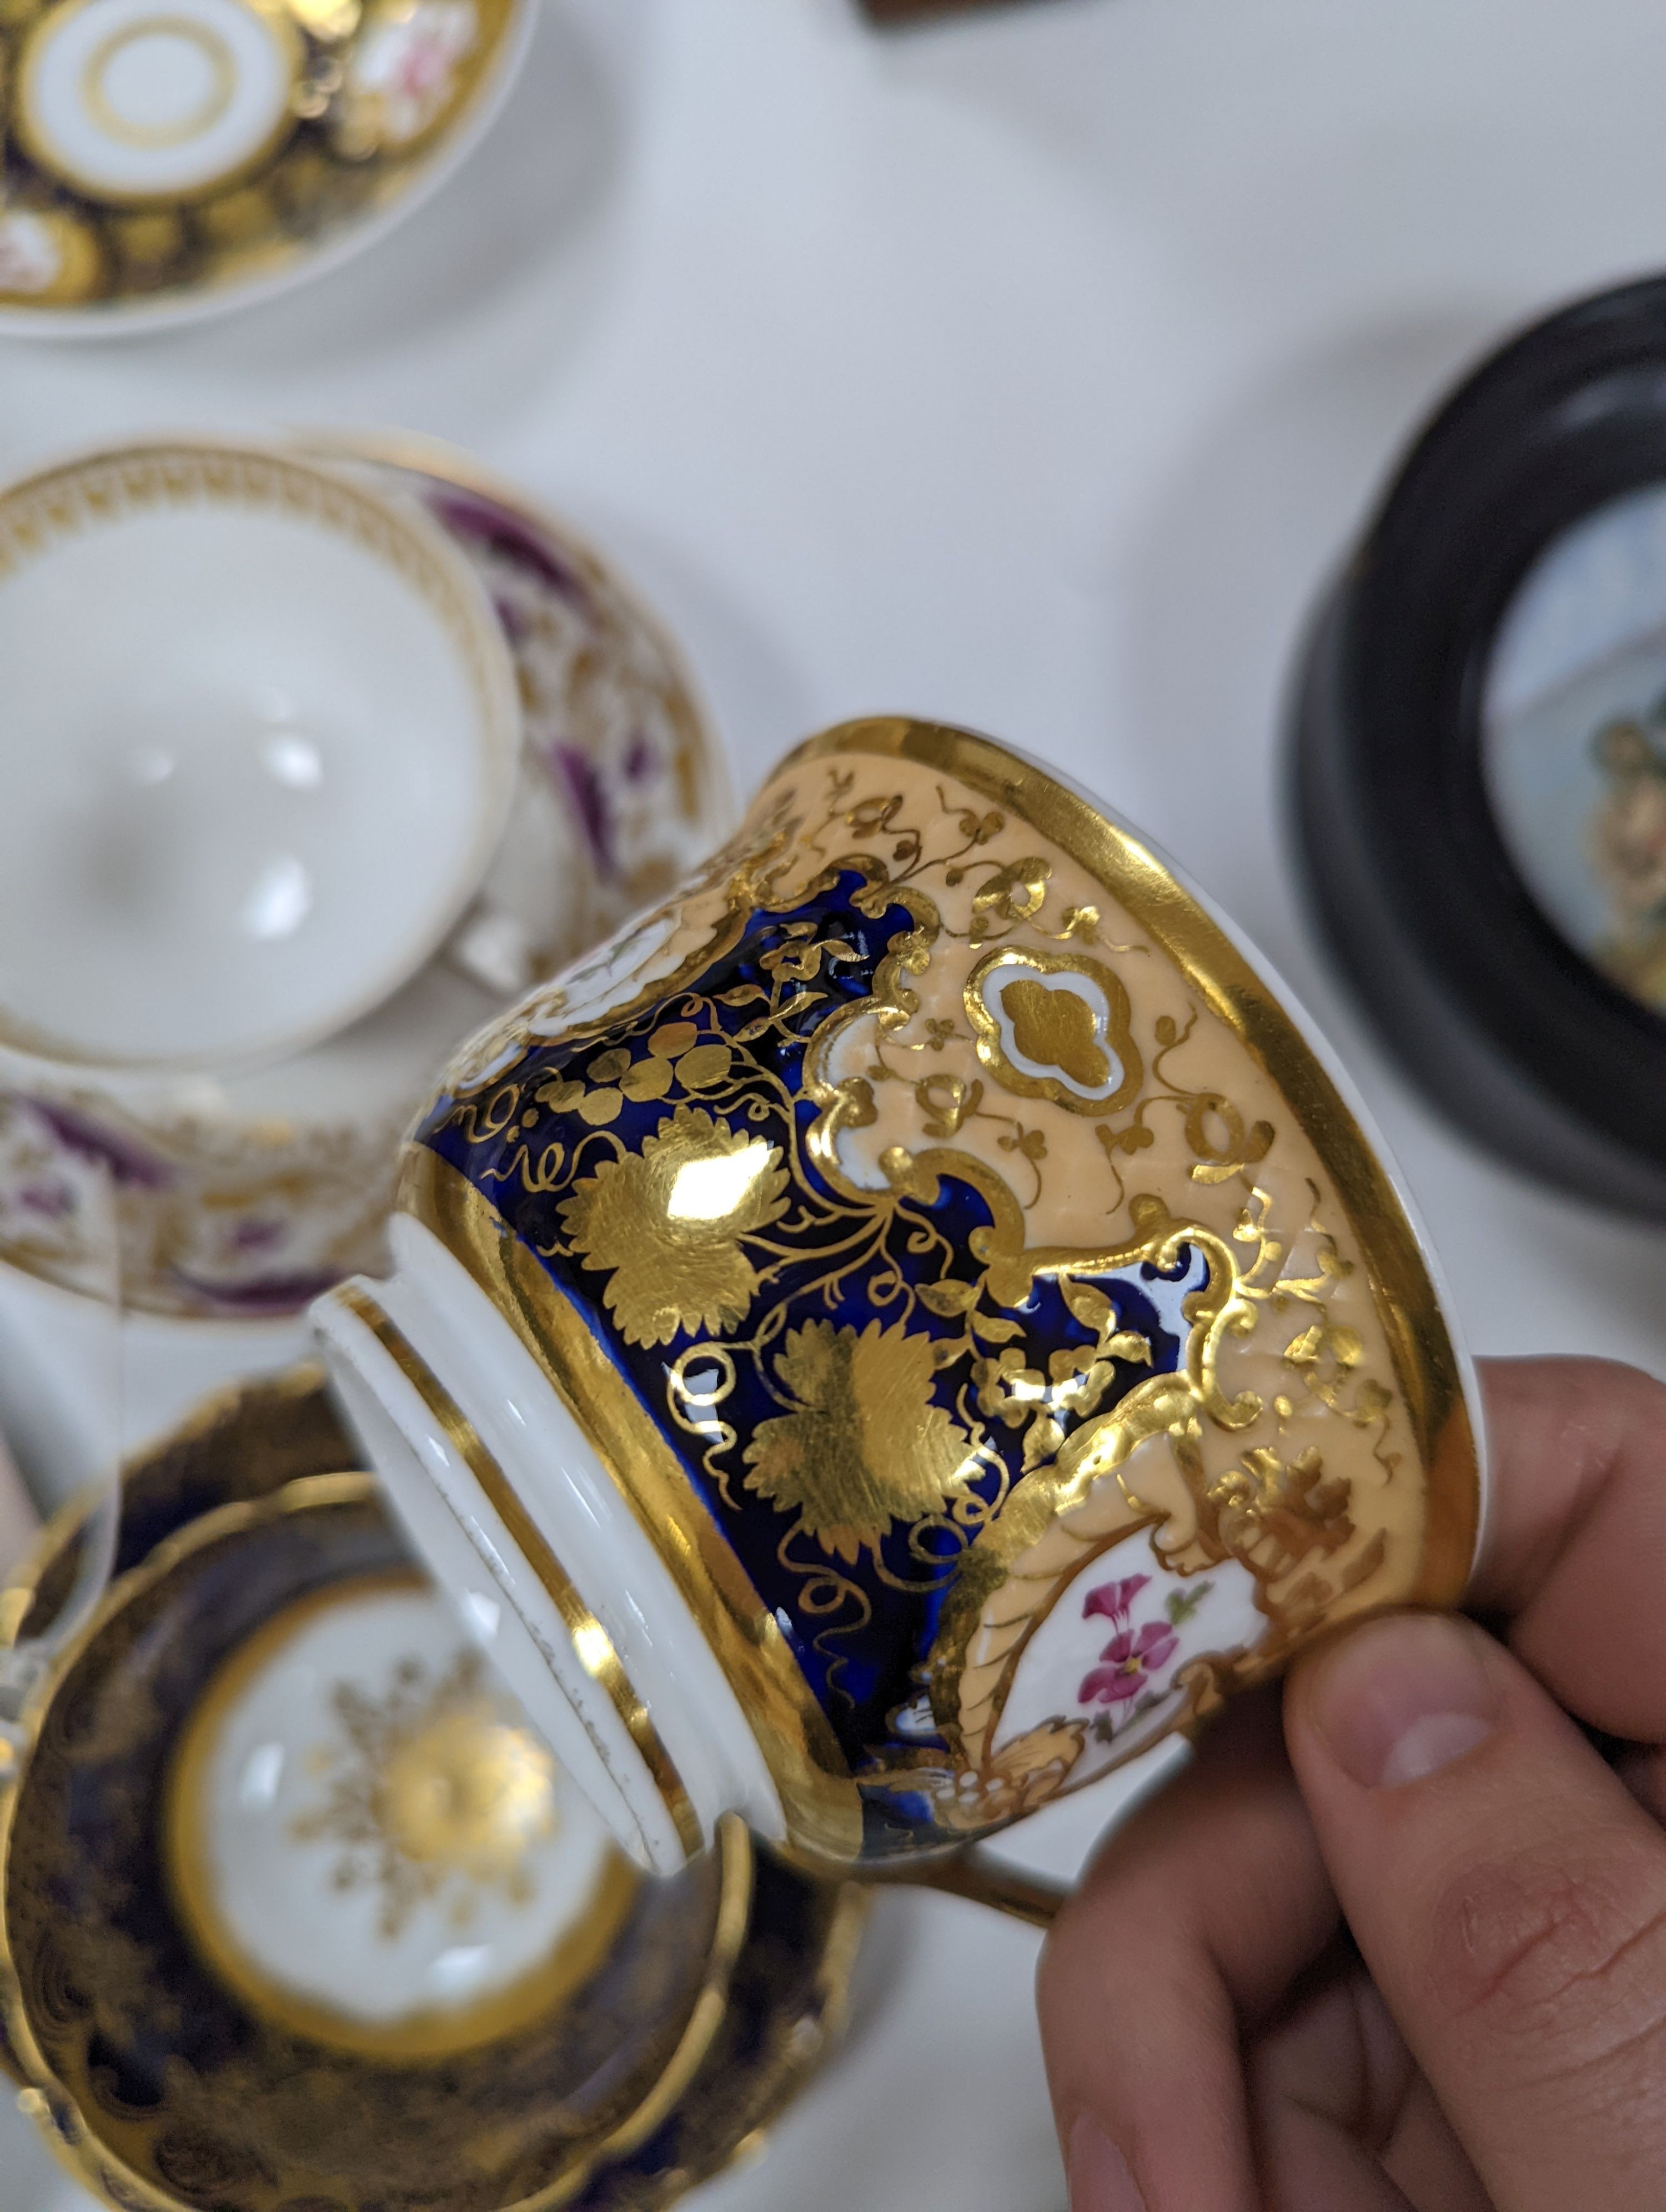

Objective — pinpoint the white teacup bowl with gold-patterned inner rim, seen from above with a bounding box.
[0,440,520,1068]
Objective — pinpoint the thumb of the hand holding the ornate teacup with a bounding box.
[1286,1615,1666,2212]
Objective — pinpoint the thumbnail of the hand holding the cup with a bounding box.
[1308,1615,1498,1789]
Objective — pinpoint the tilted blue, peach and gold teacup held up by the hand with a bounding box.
[317,719,1482,1869]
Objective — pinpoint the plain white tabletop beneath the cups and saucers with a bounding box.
[0,0,1666,2212]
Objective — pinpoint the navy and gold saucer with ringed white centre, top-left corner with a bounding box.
[0,0,533,336]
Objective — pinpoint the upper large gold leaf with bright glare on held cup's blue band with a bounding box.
[562,1093,787,1345]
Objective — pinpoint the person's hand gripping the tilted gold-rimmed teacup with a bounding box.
[1040,1360,1666,2212]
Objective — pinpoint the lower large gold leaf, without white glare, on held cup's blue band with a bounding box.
[746,1320,976,1562]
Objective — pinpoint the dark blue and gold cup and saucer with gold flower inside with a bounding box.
[0,1369,863,2212]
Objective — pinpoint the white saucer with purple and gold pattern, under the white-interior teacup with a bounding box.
[0,438,730,1318]
